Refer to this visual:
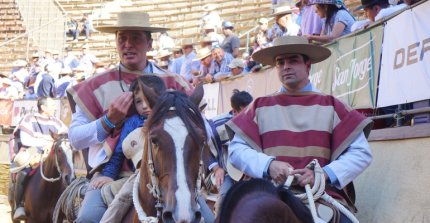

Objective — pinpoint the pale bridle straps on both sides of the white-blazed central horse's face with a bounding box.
[133,114,207,223]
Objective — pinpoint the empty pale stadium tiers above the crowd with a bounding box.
[0,0,361,72]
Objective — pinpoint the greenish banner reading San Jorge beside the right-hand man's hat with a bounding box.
[309,26,383,108]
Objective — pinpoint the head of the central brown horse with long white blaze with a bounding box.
[133,84,209,223]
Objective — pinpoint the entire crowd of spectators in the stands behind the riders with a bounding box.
[0,0,416,100]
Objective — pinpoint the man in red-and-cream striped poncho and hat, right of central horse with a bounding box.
[227,36,372,222]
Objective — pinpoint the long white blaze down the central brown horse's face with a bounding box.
[164,117,191,221]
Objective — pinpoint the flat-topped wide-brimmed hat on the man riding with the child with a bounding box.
[95,12,168,33]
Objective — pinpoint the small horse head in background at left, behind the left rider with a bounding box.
[50,132,75,186]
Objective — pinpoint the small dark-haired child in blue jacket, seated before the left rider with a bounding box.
[77,74,166,222]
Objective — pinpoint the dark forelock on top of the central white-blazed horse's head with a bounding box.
[145,91,205,143]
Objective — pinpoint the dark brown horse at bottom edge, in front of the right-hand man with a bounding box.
[216,179,313,223]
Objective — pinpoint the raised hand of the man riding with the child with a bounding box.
[107,92,133,125]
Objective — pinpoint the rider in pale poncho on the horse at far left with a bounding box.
[9,97,68,220]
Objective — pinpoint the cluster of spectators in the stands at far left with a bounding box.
[0,45,101,100]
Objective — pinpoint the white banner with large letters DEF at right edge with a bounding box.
[377,1,430,107]
